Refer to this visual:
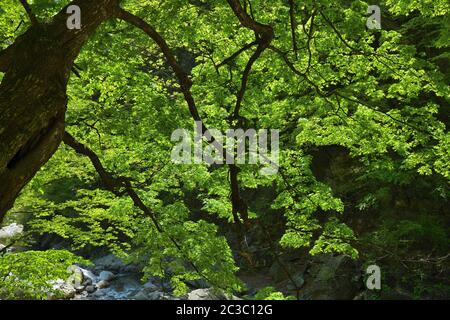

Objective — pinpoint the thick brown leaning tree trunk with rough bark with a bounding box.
[0,0,120,222]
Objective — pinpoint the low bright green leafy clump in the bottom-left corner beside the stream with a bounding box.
[0,250,89,299]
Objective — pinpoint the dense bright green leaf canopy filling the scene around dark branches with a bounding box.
[0,0,450,299]
